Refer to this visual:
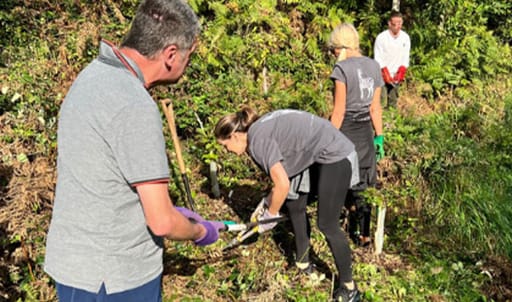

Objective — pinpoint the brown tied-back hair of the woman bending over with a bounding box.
[214,106,259,139]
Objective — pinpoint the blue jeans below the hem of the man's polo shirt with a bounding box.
[56,274,162,302]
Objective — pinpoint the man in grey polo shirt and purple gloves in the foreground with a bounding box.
[44,0,223,302]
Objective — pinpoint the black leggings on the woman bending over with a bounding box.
[286,159,352,283]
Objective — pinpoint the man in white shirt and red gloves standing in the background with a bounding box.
[373,11,411,108]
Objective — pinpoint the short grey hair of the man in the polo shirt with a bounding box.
[121,0,201,58]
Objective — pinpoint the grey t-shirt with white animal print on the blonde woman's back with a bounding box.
[331,56,384,119]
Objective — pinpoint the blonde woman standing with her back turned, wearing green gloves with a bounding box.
[329,23,384,250]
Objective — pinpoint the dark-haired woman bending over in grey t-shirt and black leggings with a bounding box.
[215,107,360,302]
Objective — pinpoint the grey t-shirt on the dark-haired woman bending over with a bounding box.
[248,110,355,178]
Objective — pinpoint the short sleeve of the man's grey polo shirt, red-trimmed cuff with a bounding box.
[109,104,169,185]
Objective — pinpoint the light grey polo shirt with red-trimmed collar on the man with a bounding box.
[44,43,169,294]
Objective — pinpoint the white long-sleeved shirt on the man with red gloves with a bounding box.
[373,29,411,77]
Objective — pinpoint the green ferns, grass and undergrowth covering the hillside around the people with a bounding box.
[0,0,512,301]
